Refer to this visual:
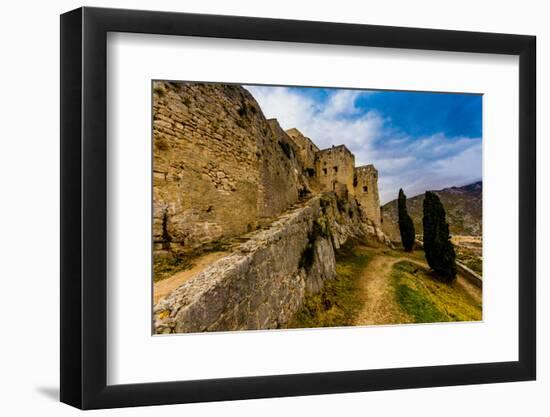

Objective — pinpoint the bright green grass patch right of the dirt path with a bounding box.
[392,261,482,323]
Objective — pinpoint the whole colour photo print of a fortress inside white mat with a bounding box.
[151,80,483,334]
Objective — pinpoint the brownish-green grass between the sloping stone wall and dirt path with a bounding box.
[286,240,369,328]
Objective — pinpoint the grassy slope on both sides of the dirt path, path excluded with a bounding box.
[286,242,482,328]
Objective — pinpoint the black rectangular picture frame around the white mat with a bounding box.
[60,7,536,409]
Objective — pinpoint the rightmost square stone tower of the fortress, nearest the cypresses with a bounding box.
[353,165,382,227]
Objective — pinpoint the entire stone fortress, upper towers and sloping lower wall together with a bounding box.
[153,81,389,333]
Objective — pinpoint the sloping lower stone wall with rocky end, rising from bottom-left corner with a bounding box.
[154,193,374,333]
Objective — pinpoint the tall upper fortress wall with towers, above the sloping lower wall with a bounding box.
[153,81,388,256]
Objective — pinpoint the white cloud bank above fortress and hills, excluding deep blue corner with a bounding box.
[246,86,481,204]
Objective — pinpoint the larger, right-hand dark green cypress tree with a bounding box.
[422,191,456,282]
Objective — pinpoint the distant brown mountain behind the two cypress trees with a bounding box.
[382,181,483,240]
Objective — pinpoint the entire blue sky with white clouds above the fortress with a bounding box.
[245,86,482,204]
